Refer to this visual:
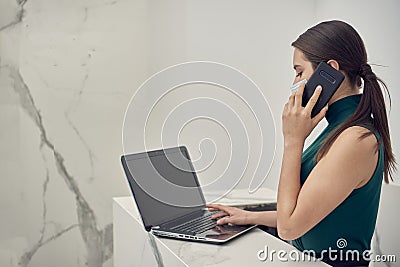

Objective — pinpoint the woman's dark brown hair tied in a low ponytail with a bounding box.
[292,20,396,183]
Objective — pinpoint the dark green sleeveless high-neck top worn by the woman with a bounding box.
[293,95,384,255]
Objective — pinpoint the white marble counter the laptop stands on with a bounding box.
[113,189,328,267]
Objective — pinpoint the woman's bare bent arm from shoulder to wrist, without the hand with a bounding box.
[277,126,378,240]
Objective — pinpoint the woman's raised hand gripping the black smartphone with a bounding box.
[282,83,328,146]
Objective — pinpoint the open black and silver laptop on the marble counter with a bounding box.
[121,146,256,244]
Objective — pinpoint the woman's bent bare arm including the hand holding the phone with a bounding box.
[277,85,378,240]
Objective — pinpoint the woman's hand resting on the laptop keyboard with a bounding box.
[207,204,251,225]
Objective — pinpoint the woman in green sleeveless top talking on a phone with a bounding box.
[208,21,395,266]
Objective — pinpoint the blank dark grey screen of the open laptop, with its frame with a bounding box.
[121,147,205,230]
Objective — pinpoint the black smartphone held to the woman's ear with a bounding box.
[302,61,344,118]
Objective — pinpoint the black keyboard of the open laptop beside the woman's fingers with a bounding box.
[171,211,219,235]
